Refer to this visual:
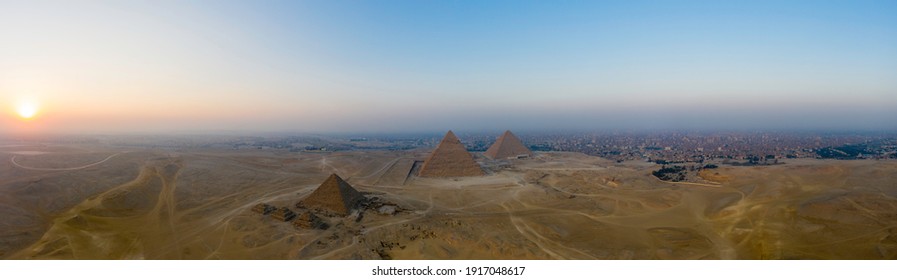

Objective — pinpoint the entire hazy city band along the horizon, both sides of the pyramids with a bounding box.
[6,131,897,164]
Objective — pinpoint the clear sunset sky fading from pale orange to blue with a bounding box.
[0,0,897,133]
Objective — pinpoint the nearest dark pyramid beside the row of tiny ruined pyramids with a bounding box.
[301,174,364,216]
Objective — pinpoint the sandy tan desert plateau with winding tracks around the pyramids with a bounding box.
[0,146,897,259]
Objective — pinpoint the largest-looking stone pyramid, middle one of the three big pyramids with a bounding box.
[418,130,485,177]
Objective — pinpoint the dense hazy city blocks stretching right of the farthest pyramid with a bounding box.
[508,132,897,162]
